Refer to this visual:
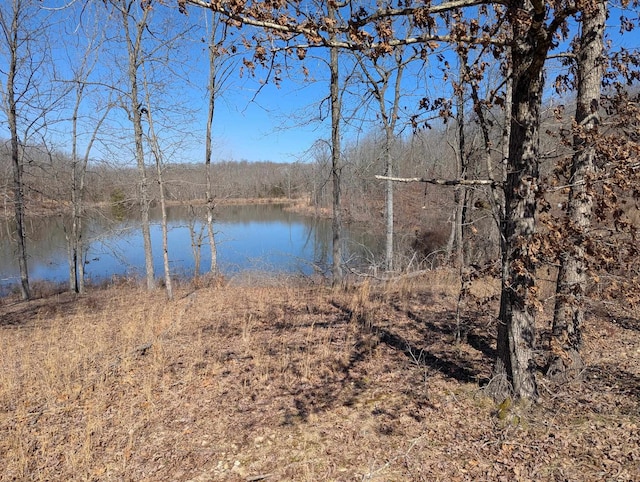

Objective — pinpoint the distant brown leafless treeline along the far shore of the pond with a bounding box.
[0,107,568,268]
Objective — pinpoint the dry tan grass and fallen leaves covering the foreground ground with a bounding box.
[0,270,640,482]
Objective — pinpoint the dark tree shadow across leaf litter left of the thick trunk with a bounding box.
[285,300,495,423]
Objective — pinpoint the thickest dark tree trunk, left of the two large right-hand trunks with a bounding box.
[496,2,553,400]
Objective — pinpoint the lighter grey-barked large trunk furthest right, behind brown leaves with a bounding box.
[548,1,607,380]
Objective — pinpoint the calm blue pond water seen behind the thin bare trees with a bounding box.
[0,205,380,289]
